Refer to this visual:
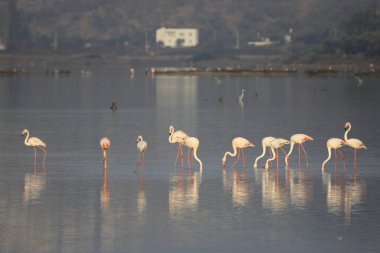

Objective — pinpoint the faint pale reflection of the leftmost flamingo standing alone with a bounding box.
[24,173,46,204]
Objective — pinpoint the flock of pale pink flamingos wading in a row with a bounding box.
[22,122,367,173]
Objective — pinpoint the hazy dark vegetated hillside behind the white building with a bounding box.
[4,0,380,57]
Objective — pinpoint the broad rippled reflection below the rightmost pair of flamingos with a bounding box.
[322,170,364,225]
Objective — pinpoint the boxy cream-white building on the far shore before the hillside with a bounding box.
[156,27,199,48]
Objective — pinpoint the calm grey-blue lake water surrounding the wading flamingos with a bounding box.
[0,67,380,252]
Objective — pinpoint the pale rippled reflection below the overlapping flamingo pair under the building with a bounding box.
[169,169,202,217]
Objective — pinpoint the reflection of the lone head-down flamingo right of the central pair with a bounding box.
[223,168,253,207]
